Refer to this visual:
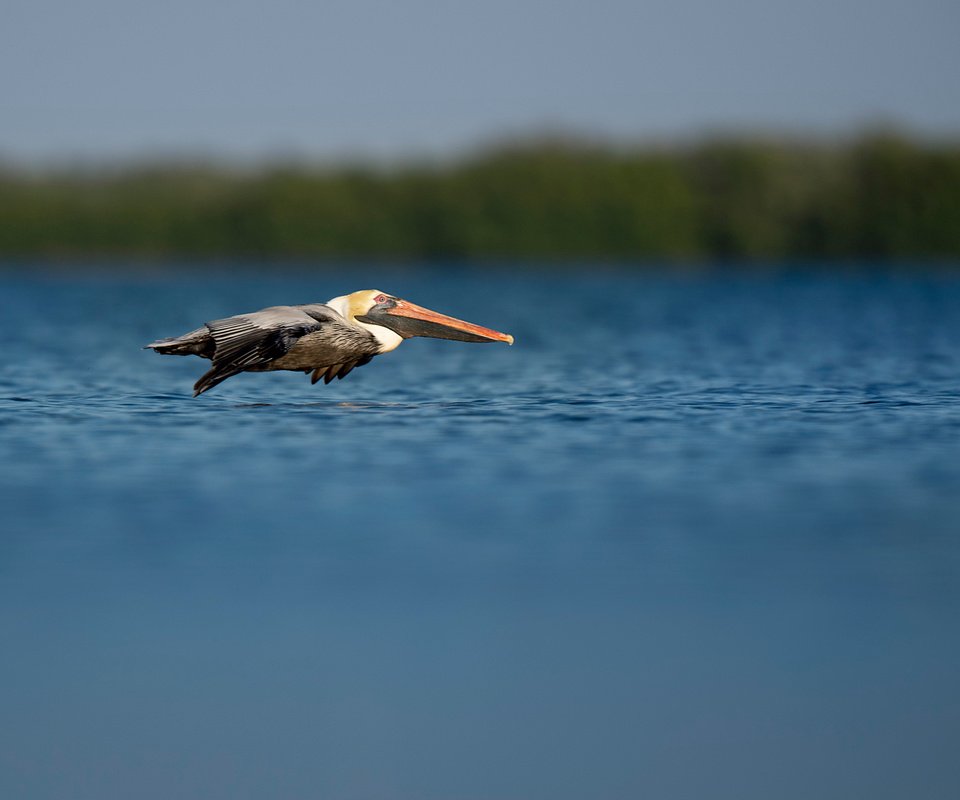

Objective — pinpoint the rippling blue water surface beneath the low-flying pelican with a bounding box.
[0,266,960,800]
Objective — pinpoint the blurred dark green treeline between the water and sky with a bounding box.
[0,135,960,261]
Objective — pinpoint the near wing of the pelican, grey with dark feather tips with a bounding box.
[193,306,324,397]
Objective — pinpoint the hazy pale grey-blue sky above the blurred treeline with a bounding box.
[0,0,960,163]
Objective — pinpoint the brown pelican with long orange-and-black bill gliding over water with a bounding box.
[144,289,513,397]
